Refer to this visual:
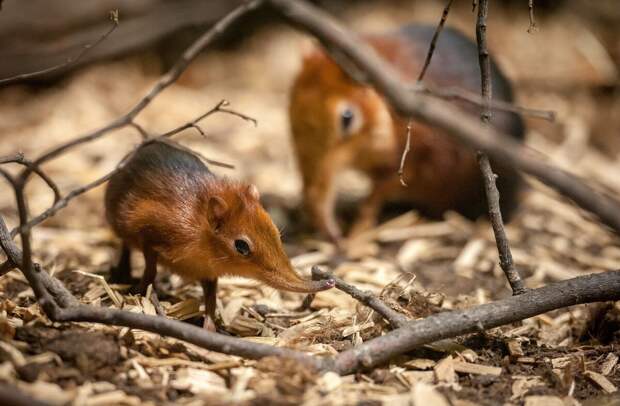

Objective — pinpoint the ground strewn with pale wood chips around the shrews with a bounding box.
[0,1,620,406]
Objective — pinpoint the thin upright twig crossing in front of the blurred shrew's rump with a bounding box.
[476,0,526,295]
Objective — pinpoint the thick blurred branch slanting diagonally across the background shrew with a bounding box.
[268,0,620,233]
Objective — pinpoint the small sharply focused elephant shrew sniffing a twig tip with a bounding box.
[105,142,334,331]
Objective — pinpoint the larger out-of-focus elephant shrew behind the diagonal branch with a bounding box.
[289,25,524,241]
